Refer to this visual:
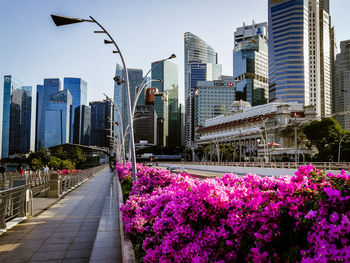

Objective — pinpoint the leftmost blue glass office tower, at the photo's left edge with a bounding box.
[1,75,34,158]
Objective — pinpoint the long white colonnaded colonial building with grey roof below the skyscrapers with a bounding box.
[195,101,316,161]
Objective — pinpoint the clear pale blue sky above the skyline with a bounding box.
[0,0,350,105]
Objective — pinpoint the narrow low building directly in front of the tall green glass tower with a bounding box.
[154,91,169,147]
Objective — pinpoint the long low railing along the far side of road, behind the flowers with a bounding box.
[163,162,350,171]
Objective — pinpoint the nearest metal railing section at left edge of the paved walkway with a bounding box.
[0,185,33,228]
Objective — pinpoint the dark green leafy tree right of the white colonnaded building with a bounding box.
[304,118,345,162]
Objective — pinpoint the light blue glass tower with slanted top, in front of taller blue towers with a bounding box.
[44,90,73,148]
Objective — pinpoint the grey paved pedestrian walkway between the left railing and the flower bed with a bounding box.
[0,169,121,263]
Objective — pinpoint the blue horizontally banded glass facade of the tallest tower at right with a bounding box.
[268,0,310,105]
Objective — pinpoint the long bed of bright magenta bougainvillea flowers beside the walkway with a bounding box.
[117,164,350,262]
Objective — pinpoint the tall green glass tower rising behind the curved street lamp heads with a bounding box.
[152,61,181,147]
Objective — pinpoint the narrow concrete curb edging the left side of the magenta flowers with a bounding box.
[116,175,136,263]
